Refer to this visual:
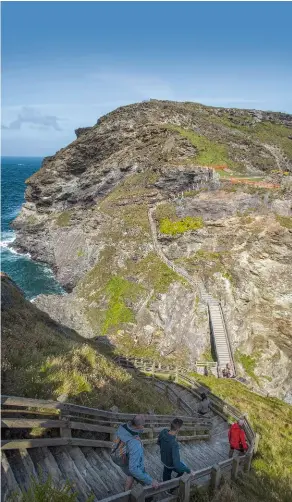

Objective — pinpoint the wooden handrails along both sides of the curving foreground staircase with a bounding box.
[1,359,259,502]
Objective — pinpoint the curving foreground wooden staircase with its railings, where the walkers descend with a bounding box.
[1,374,255,502]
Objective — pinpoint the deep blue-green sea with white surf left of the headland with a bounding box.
[1,157,64,300]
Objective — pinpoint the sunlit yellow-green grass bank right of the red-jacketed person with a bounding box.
[187,374,292,490]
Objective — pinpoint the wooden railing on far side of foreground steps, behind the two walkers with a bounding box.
[1,388,212,450]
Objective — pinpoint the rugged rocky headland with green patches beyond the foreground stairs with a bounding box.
[14,101,292,398]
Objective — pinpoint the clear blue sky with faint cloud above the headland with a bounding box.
[1,2,292,156]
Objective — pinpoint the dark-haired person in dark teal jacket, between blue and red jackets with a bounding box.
[157,418,191,481]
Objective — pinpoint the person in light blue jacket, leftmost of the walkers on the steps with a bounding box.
[116,415,159,491]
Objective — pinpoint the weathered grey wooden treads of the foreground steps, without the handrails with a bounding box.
[2,382,233,502]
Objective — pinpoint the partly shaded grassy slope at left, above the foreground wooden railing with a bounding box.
[1,276,171,413]
